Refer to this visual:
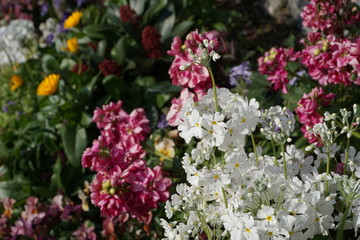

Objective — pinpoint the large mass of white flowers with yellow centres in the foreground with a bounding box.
[161,89,352,240]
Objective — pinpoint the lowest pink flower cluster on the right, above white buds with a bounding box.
[295,88,335,143]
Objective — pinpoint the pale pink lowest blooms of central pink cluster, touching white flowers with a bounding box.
[166,88,194,126]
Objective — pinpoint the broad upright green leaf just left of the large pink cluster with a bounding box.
[60,125,87,167]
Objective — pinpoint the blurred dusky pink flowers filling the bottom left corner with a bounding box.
[0,194,81,239]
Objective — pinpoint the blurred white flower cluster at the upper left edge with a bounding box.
[0,19,36,66]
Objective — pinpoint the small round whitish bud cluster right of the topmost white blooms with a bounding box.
[260,106,295,144]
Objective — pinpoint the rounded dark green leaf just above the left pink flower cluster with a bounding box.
[102,75,129,100]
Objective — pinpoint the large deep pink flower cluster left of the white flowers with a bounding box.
[82,101,171,220]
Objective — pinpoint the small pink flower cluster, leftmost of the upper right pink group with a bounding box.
[258,47,299,93]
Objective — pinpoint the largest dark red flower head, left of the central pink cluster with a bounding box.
[141,26,162,58]
